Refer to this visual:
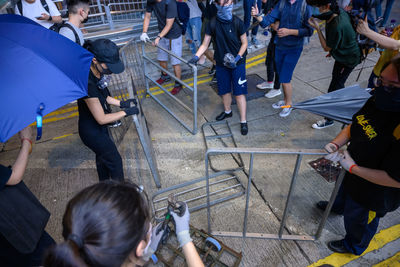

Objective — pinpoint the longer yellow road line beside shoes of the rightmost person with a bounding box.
[308,224,400,267]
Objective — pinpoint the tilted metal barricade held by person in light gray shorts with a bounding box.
[142,43,197,134]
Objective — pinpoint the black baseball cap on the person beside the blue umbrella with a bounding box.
[85,39,125,74]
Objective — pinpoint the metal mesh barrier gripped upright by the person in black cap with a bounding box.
[108,40,161,188]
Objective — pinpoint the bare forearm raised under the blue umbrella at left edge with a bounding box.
[6,126,32,185]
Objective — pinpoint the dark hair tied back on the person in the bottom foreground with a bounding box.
[44,181,150,267]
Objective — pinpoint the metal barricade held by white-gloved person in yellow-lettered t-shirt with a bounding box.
[205,148,346,241]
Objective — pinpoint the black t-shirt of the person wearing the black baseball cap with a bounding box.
[78,72,111,130]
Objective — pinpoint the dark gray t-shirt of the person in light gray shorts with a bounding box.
[146,0,182,39]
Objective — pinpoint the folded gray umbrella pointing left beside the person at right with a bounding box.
[292,84,371,123]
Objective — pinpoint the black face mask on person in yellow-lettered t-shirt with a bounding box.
[374,86,400,112]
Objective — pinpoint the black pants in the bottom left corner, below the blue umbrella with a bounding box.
[0,231,56,267]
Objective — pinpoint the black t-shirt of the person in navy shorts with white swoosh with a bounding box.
[205,16,247,66]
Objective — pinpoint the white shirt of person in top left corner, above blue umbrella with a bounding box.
[15,0,61,29]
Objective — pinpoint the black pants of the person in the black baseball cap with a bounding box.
[79,124,124,181]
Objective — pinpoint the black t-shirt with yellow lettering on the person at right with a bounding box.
[344,97,400,212]
